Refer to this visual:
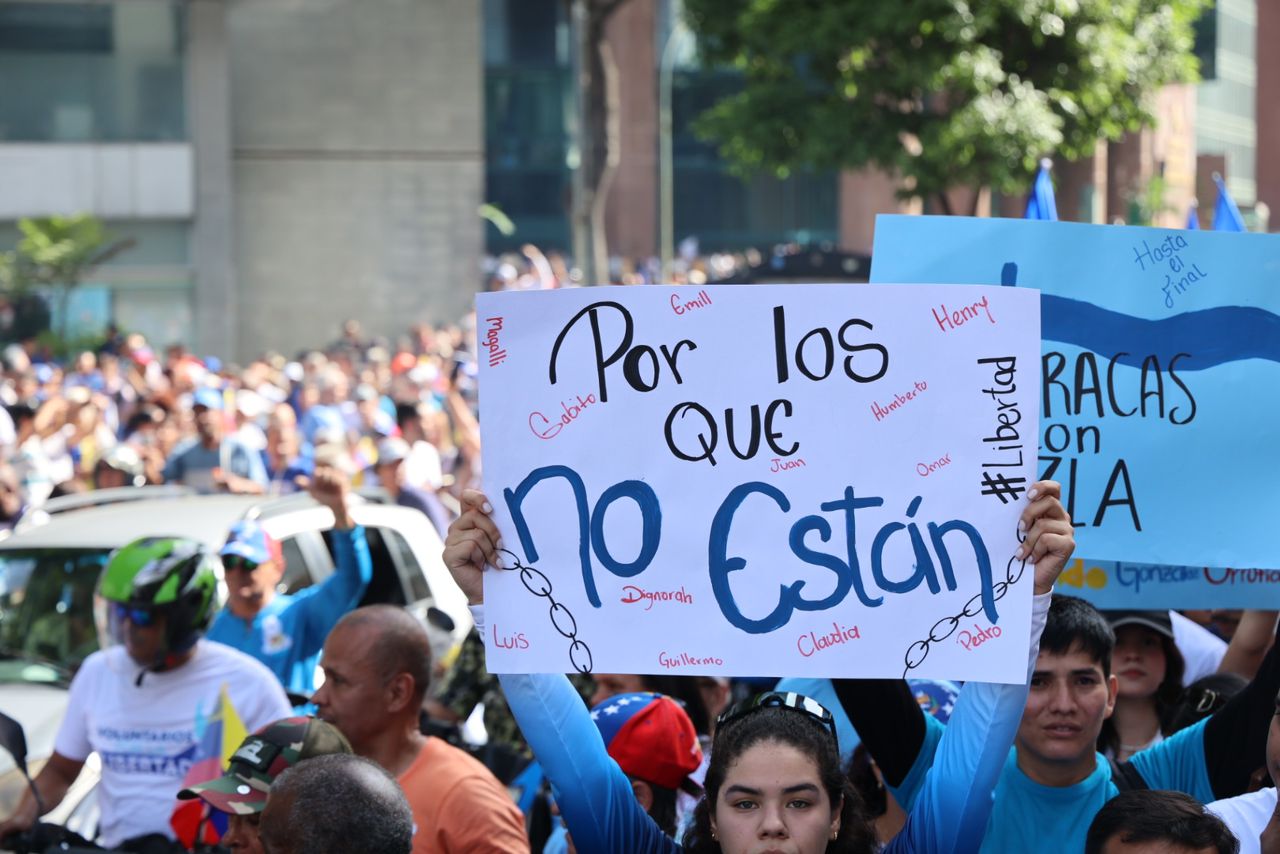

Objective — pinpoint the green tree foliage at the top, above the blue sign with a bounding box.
[685,0,1210,213]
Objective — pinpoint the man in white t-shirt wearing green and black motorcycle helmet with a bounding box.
[0,538,291,850]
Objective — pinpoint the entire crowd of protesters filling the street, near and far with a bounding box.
[0,308,1280,854]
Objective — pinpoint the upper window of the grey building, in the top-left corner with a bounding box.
[0,0,187,142]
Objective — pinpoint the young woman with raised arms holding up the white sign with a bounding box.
[444,481,1075,854]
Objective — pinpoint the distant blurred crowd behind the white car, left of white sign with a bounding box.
[0,321,480,534]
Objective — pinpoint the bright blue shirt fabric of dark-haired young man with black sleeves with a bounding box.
[892,714,1213,854]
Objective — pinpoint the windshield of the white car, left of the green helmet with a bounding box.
[0,549,110,682]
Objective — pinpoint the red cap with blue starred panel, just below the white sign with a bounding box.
[591,693,703,789]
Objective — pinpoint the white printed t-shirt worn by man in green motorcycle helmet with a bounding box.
[54,640,292,848]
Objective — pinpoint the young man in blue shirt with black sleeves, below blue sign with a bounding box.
[837,594,1280,854]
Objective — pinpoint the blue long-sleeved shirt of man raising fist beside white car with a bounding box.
[206,525,372,697]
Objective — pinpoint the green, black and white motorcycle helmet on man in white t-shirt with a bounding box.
[97,536,218,670]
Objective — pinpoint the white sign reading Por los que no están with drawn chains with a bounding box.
[476,286,1039,682]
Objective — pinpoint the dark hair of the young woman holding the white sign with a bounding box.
[684,707,876,854]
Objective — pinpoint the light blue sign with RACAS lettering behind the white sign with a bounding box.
[870,216,1280,583]
